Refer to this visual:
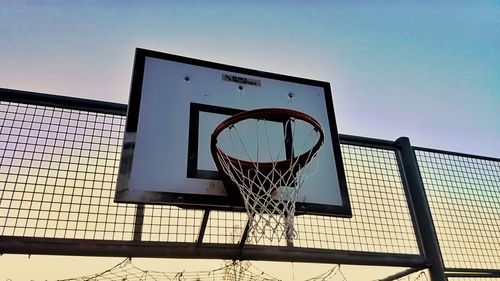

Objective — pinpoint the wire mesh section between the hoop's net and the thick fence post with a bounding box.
[294,144,419,254]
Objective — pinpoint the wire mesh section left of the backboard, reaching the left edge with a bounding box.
[0,101,135,240]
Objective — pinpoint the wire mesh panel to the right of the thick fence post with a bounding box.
[415,149,500,270]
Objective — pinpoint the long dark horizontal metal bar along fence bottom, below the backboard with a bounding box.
[0,236,426,267]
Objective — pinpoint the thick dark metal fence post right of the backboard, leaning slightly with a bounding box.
[396,137,447,281]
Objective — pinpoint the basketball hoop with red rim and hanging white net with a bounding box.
[210,108,324,243]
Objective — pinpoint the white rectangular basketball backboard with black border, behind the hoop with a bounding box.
[115,49,351,216]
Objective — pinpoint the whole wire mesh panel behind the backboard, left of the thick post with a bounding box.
[0,91,446,266]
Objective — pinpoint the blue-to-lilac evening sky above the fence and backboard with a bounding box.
[0,1,500,157]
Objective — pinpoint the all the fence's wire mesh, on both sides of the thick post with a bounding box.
[0,94,500,280]
